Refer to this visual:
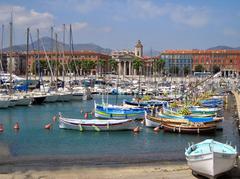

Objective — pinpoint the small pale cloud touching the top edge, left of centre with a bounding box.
[75,0,103,13]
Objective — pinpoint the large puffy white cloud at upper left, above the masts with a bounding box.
[0,5,54,29]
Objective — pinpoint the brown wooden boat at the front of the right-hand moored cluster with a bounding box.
[161,122,217,134]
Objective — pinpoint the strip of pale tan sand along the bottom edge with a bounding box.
[0,163,194,179]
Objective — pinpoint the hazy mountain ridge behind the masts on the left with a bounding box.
[3,37,112,54]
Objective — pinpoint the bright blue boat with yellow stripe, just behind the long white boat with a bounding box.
[95,103,145,119]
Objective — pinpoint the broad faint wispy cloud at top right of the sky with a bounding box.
[119,0,209,27]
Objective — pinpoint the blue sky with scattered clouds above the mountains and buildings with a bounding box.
[0,0,240,50]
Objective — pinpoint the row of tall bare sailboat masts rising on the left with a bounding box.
[0,16,78,94]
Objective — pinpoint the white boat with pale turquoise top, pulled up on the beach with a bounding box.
[185,139,237,178]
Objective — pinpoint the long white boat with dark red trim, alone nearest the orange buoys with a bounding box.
[59,114,138,132]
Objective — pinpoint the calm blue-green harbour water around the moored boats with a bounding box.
[0,96,240,160]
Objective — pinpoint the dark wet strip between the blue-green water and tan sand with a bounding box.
[0,155,186,173]
